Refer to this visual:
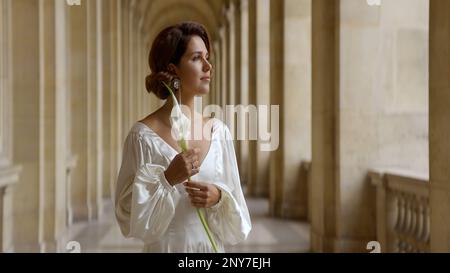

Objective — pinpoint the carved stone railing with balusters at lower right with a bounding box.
[369,170,430,252]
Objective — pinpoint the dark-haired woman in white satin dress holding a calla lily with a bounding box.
[115,22,251,252]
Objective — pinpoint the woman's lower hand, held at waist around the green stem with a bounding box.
[184,181,221,208]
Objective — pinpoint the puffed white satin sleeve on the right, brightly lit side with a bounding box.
[206,124,252,245]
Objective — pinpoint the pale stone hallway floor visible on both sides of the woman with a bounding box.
[71,198,310,253]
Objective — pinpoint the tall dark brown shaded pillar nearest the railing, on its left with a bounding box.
[311,0,339,252]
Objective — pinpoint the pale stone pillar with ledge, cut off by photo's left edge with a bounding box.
[0,0,21,252]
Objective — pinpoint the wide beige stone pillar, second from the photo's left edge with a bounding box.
[10,0,43,252]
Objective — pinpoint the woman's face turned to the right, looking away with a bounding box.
[175,36,212,96]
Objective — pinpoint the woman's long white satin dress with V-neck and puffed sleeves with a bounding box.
[115,119,251,253]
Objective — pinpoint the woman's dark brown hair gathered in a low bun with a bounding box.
[145,22,210,100]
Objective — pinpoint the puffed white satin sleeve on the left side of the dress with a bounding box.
[115,133,180,243]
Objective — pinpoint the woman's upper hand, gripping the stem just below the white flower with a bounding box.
[164,148,200,186]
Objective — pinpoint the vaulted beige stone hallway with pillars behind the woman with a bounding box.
[0,0,450,252]
